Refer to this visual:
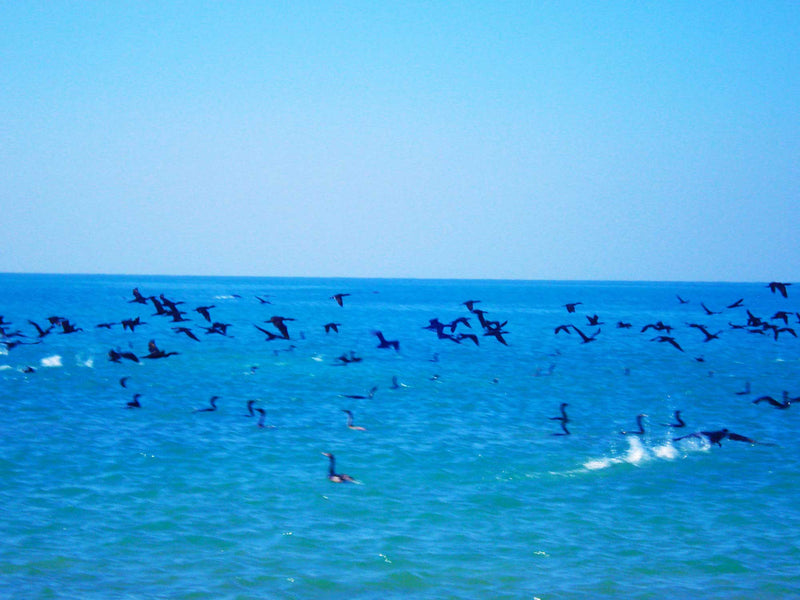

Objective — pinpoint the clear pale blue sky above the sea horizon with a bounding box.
[0,0,800,281]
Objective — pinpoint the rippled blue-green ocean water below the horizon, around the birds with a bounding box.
[0,274,800,599]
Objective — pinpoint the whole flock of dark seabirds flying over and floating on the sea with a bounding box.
[0,282,800,483]
